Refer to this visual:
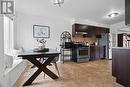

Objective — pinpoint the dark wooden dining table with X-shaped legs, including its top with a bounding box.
[18,50,60,86]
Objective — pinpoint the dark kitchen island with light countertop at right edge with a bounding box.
[112,47,130,87]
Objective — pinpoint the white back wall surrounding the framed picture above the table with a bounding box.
[15,13,72,50]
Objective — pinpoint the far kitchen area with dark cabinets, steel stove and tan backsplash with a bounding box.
[61,23,109,62]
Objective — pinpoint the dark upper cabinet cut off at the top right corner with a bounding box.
[125,0,130,25]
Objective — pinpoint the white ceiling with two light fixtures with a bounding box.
[16,0,125,24]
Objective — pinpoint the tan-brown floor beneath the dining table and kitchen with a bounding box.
[14,60,123,87]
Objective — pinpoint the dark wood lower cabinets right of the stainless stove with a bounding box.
[90,46,105,60]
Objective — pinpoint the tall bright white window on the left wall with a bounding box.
[4,16,14,69]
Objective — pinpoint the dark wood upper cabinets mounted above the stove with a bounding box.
[72,24,109,37]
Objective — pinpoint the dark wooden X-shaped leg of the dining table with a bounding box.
[23,56,58,86]
